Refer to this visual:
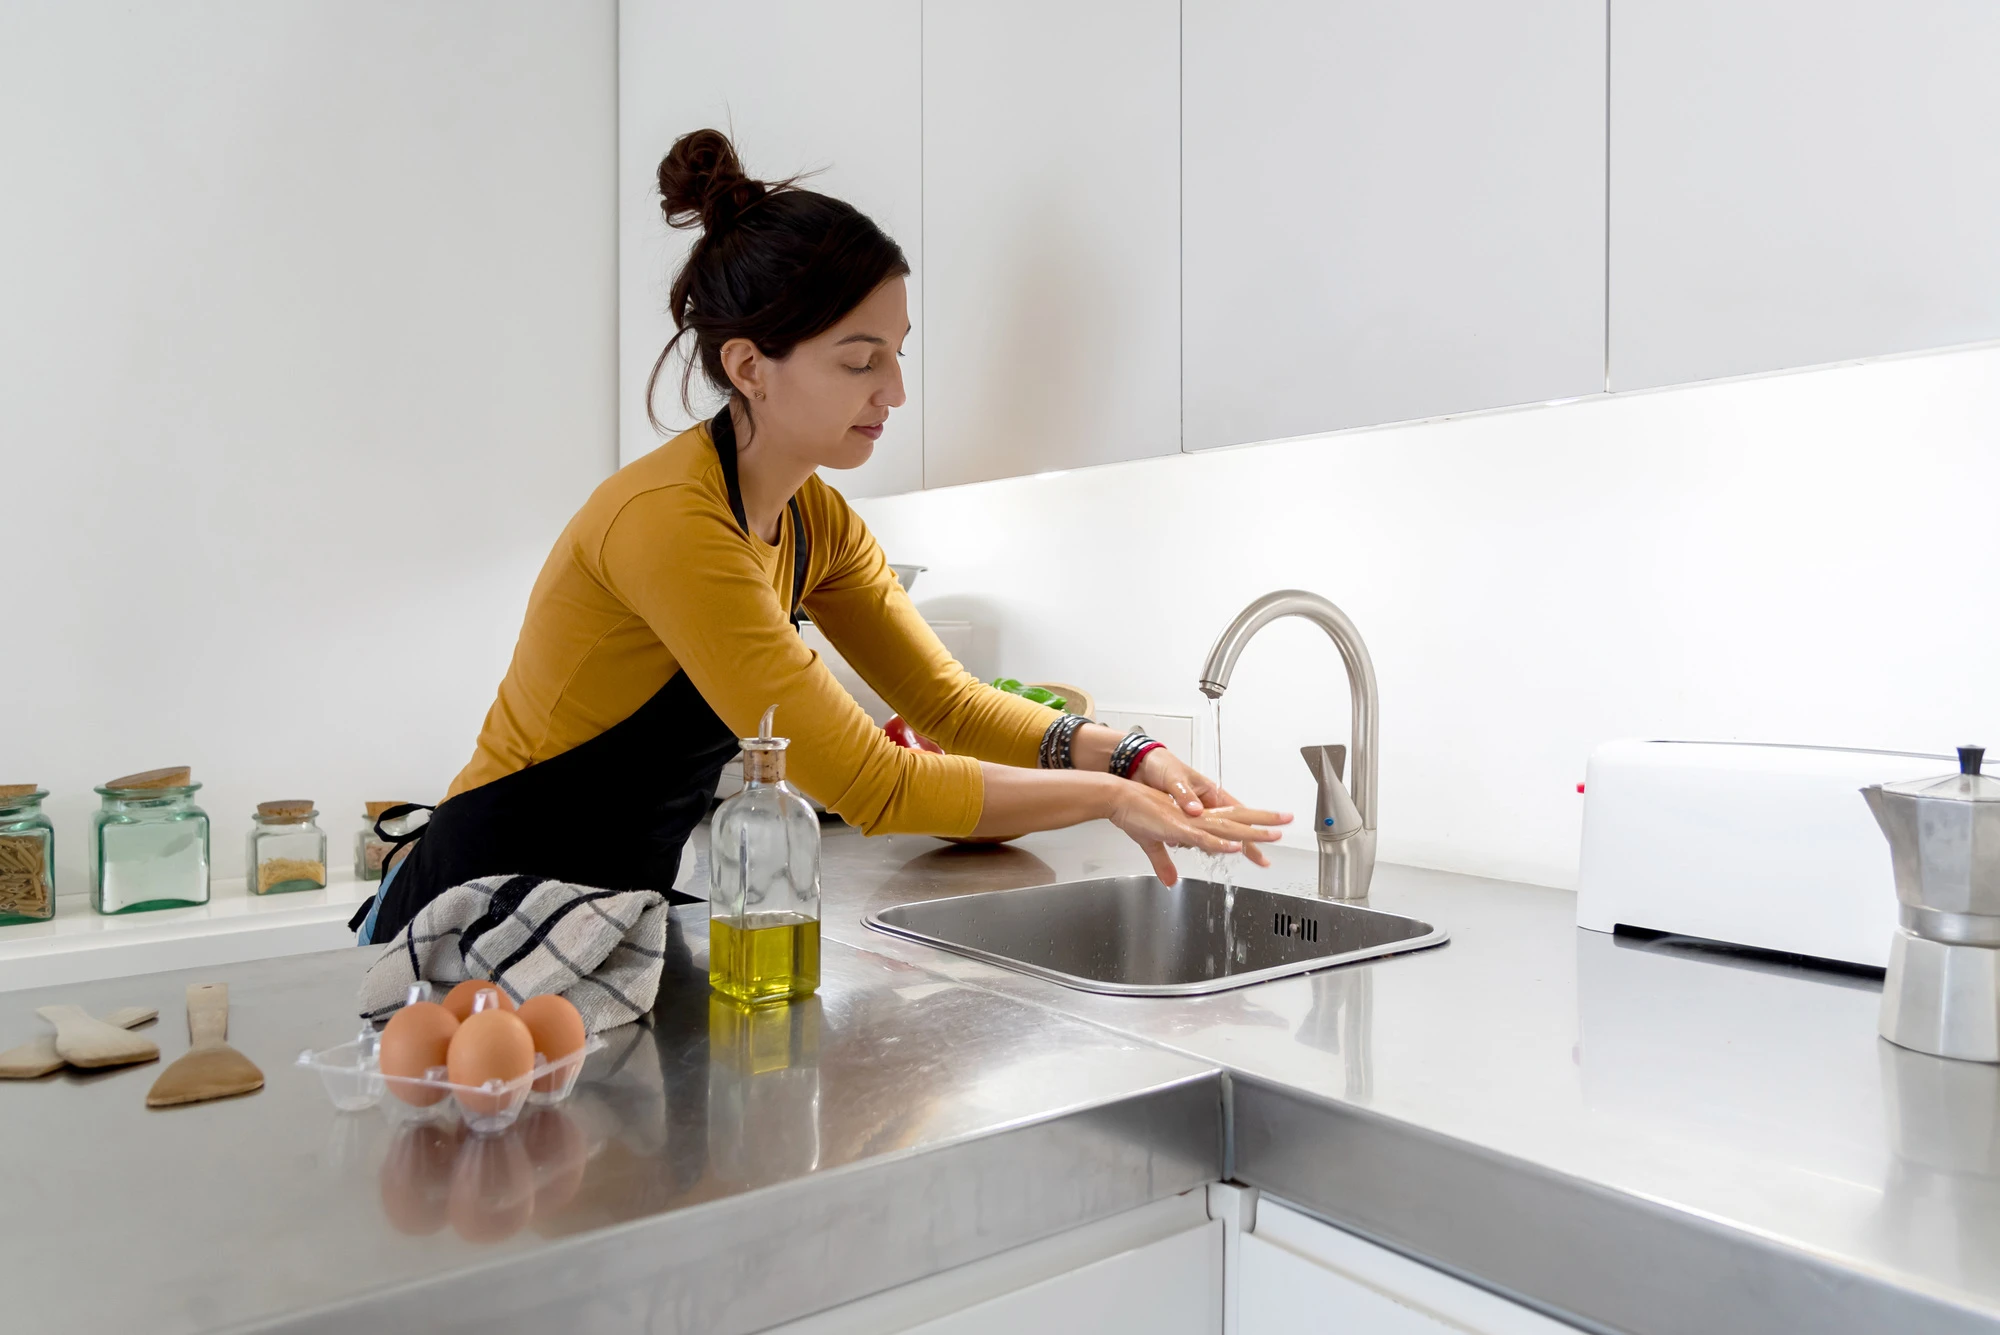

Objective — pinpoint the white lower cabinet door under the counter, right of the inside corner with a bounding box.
[1230,1197,1574,1335]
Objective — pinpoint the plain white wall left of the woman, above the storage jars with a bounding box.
[0,0,618,891]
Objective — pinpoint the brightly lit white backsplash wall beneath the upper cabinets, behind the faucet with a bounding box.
[860,346,2000,885]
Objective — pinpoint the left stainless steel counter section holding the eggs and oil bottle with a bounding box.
[0,911,1222,1335]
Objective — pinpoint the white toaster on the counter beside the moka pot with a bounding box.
[1576,741,1956,967]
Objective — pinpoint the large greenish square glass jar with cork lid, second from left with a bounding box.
[90,765,208,913]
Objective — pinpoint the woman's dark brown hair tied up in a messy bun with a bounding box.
[646,130,910,434]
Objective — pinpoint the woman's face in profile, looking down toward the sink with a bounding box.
[740,278,910,468]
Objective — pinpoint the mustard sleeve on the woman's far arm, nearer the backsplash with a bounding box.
[806,488,1058,769]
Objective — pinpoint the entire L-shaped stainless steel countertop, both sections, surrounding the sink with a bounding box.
[15,825,2000,1335]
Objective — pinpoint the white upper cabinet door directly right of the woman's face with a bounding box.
[924,0,1180,486]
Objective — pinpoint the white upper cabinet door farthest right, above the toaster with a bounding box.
[1610,0,2000,390]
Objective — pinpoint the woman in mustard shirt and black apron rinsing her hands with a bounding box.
[362,130,1290,941]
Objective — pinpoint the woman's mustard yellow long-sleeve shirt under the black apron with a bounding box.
[450,424,1054,835]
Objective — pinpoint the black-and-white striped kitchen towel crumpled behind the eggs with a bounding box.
[362,875,668,1033]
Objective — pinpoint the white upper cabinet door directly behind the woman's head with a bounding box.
[618,0,924,496]
